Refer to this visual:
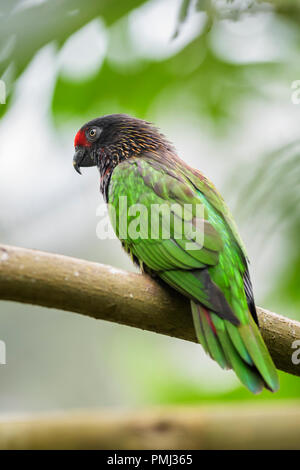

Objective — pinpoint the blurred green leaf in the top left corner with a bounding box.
[0,0,145,89]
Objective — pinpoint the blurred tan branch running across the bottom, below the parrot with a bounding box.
[0,402,300,450]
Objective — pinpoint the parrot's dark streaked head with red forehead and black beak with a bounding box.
[73,114,170,174]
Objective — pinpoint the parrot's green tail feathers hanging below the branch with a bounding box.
[191,301,278,393]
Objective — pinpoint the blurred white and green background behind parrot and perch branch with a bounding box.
[0,0,300,413]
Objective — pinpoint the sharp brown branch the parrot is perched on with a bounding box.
[0,245,300,376]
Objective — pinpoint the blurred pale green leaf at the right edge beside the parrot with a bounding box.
[229,140,300,318]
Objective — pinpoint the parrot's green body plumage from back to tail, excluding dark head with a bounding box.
[108,150,278,393]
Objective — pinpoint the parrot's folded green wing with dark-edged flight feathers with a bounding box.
[109,159,239,323]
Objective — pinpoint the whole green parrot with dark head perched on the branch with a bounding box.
[73,114,279,393]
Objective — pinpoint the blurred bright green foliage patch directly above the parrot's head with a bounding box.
[53,34,276,128]
